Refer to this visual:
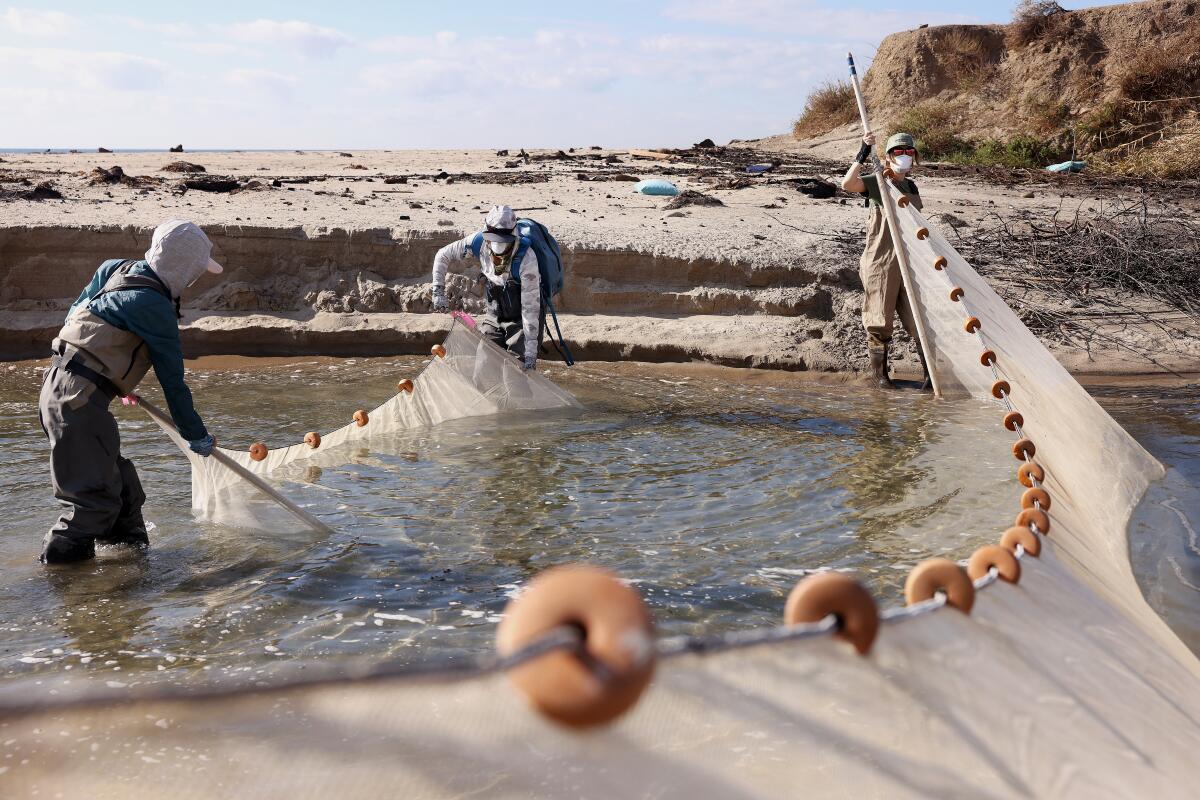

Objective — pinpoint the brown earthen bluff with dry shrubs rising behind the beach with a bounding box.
[794,0,1200,179]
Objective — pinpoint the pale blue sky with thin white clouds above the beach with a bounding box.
[0,0,1118,149]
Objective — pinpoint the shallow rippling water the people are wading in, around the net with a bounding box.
[0,359,1200,697]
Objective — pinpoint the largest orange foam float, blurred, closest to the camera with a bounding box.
[496,565,654,728]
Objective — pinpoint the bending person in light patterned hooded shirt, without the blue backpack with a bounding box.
[433,205,542,369]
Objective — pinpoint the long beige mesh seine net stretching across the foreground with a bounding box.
[0,214,1200,800]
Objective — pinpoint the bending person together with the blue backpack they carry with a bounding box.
[433,205,574,369]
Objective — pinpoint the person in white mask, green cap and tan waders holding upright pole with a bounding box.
[841,133,929,389]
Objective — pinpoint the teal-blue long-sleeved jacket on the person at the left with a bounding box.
[74,259,209,441]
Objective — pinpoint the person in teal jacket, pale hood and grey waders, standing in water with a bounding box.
[38,219,221,564]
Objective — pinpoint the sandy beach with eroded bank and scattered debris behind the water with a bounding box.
[0,136,1200,374]
